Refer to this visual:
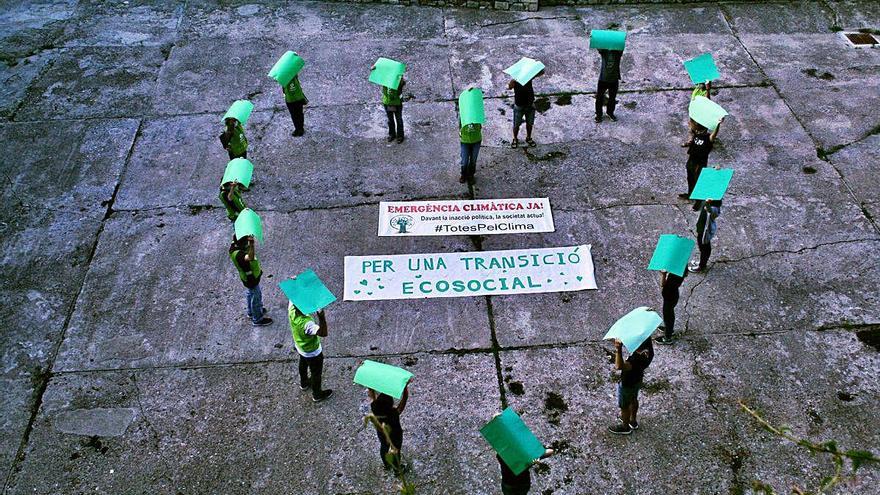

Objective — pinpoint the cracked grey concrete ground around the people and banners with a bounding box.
[0,0,880,495]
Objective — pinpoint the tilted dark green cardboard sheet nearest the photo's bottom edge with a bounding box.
[480,407,544,474]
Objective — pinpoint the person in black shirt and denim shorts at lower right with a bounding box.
[608,337,654,435]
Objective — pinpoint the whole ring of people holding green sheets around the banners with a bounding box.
[219,30,732,495]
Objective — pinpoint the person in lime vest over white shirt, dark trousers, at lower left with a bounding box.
[287,302,333,402]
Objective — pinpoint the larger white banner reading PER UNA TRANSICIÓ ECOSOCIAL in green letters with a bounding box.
[345,244,597,301]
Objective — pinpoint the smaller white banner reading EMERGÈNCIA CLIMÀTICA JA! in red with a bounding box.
[379,198,555,236]
